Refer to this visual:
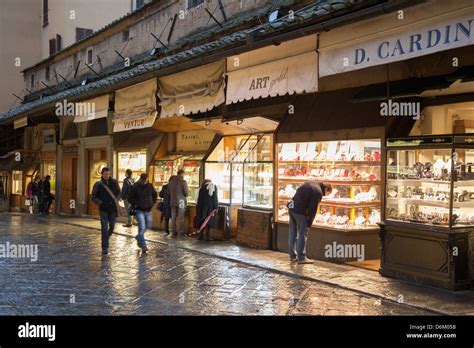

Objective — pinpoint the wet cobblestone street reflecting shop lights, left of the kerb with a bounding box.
[0,214,432,315]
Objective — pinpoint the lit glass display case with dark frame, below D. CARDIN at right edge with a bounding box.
[385,135,474,228]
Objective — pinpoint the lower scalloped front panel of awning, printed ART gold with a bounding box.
[226,52,318,104]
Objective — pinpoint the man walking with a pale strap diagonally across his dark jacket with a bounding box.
[92,167,120,254]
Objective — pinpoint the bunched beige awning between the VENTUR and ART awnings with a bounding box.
[158,61,225,118]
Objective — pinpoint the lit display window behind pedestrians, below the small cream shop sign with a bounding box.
[153,155,203,203]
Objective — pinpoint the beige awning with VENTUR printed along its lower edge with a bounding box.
[114,79,157,133]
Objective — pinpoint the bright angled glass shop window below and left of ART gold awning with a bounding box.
[205,134,273,209]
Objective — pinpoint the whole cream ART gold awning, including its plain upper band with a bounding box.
[226,35,318,104]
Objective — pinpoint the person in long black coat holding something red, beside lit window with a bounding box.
[196,179,219,241]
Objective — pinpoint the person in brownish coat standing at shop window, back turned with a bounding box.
[168,169,189,237]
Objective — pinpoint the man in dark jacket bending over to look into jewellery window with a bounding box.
[288,181,332,264]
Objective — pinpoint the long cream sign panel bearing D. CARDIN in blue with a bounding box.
[319,10,474,77]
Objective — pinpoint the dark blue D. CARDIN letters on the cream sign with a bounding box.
[354,19,474,65]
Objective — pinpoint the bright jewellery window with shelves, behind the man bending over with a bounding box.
[277,140,381,230]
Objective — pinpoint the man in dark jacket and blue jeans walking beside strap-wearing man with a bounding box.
[128,173,158,252]
